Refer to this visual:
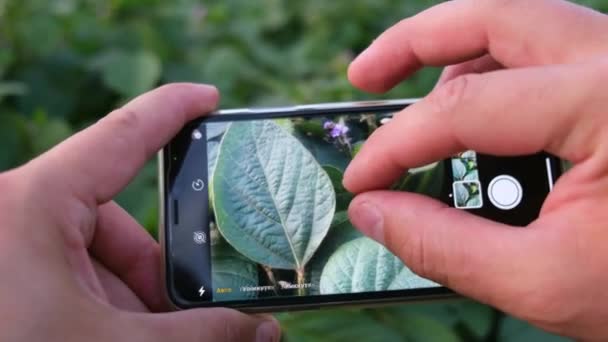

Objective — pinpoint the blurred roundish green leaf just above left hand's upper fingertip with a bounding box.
[98,50,162,98]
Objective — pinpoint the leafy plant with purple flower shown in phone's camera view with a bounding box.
[208,119,440,299]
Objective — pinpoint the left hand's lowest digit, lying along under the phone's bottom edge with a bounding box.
[131,308,281,342]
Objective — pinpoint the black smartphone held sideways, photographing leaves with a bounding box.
[159,100,561,312]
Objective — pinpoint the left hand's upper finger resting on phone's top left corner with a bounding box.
[34,83,218,204]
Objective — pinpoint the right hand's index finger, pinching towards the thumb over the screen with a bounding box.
[344,61,608,192]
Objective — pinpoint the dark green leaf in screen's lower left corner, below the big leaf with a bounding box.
[211,240,258,300]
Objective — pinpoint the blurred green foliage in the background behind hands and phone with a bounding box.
[0,0,608,341]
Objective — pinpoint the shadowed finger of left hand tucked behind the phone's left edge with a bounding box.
[87,202,168,311]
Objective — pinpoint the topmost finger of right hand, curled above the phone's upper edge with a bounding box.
[348,0,608,92]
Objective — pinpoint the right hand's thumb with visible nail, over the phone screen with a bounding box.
[348,191,533,307]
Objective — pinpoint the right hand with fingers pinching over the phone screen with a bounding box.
[344,0,608,340]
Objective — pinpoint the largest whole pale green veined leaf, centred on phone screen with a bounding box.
[211,121,336,270]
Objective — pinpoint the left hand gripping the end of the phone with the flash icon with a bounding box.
[0,84,279,342]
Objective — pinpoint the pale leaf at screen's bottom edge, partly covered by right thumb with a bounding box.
[320,237,437,294]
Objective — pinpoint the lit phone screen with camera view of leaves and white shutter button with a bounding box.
[175,112,553,302]
